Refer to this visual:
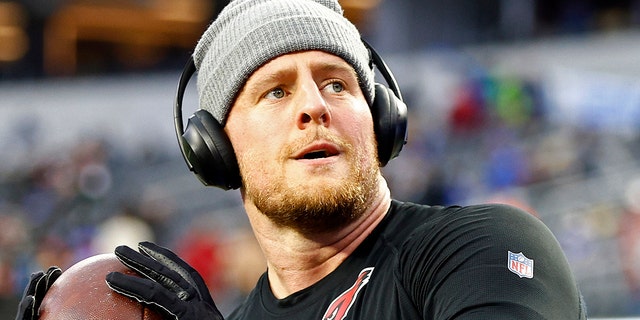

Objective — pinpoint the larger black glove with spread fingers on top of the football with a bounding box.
[107,242,224,320]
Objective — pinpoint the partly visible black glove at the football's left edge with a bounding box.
[16,267,62,320]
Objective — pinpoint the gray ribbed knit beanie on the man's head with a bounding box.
[193,0,375,124]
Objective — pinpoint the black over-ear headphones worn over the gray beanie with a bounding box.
[173,41,407,190]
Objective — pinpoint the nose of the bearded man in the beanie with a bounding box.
[296,82,331,129]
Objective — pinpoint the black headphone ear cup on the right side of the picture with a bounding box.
[371,83,407,166]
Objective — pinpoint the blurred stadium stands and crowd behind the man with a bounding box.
[0,0,640,318]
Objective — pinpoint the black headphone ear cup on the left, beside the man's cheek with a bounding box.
[180,110,241,190]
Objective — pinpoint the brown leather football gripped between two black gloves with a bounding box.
[40,254,162,320]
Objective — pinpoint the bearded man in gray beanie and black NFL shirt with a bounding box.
[16,0,585,320]
